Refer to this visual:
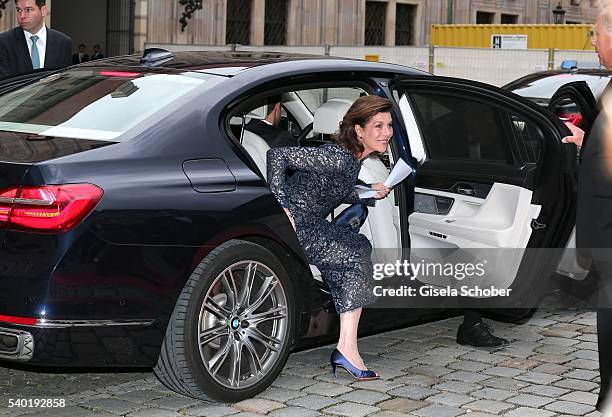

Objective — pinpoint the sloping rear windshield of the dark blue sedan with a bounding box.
[0,70,226,140]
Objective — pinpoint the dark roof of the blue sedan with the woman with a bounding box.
[75,51,427,75]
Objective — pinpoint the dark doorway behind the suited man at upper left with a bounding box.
[49,0,134,56]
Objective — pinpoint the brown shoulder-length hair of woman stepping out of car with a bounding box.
[333,96,393,156]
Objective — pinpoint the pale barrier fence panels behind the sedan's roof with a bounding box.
[146,44,598,86]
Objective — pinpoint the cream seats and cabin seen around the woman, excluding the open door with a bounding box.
[230,87,402,281]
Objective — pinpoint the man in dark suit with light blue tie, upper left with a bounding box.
[0,0,72,79]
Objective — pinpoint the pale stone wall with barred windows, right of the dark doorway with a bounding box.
[146,0,598,46]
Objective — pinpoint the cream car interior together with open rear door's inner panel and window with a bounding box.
[229,83,580,294]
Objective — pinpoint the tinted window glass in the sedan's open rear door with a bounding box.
[411,93,510,161]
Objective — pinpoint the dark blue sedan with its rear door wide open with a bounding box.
[0,50,575,401]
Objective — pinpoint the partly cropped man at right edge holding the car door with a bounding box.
[563,1,612,415]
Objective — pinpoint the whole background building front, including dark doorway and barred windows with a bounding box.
[0,0,598,55]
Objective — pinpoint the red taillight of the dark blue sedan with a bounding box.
[0,184,102,233]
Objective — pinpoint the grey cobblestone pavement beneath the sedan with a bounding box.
[0,310,601,417]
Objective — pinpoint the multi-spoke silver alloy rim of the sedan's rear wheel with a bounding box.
[198,260,289,389]
